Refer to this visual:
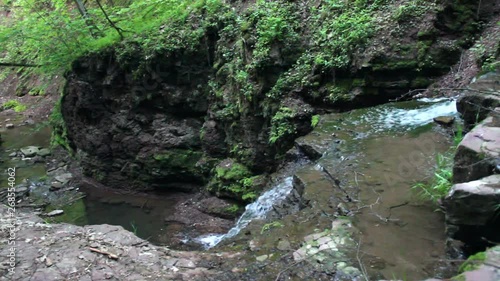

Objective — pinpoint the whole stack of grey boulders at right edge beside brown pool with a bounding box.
[443,73,500,249]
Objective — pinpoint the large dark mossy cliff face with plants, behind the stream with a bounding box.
[61,0,491,199]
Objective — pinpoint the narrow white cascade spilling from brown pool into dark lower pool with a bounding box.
[194,177,292,249]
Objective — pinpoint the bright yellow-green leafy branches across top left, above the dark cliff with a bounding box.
[0,0,223,74]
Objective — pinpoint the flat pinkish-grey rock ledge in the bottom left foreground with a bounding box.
[0,205,238,281]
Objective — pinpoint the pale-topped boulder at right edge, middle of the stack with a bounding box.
[453,110,500,183]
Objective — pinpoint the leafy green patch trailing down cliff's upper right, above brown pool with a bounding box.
[267,0,385,101]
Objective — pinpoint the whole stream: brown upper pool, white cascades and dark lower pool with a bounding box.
[0,97,456,280]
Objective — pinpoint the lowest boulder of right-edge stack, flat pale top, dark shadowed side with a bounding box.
[443,175,500,226]
